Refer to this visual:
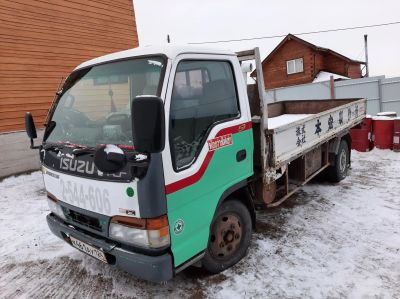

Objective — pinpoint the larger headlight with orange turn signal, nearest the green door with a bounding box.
[109,215,170,248]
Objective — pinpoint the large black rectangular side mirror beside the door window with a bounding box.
[131,96,165,153]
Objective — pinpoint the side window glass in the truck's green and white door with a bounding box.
[170,60,239,170]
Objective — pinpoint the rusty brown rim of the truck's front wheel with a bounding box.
[210,213,242,260]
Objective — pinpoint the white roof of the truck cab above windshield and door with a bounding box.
[75,44,236,70]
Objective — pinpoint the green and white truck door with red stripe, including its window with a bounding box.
[163,54,253,266]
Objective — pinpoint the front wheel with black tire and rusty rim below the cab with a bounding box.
[202,200,252,274]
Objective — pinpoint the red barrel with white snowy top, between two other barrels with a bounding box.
[373,116,394,149]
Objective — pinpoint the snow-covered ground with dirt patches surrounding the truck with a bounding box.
[0,150,400,298]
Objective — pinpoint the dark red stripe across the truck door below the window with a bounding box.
[165,122,252,194]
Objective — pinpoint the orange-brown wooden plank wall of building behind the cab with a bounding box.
[0,0,138,133]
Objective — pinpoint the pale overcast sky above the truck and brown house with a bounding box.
[133,0,400,77]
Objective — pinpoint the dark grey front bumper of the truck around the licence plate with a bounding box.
[47,214,174,282]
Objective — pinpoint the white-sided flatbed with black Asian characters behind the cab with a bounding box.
[237,48,367,207]
